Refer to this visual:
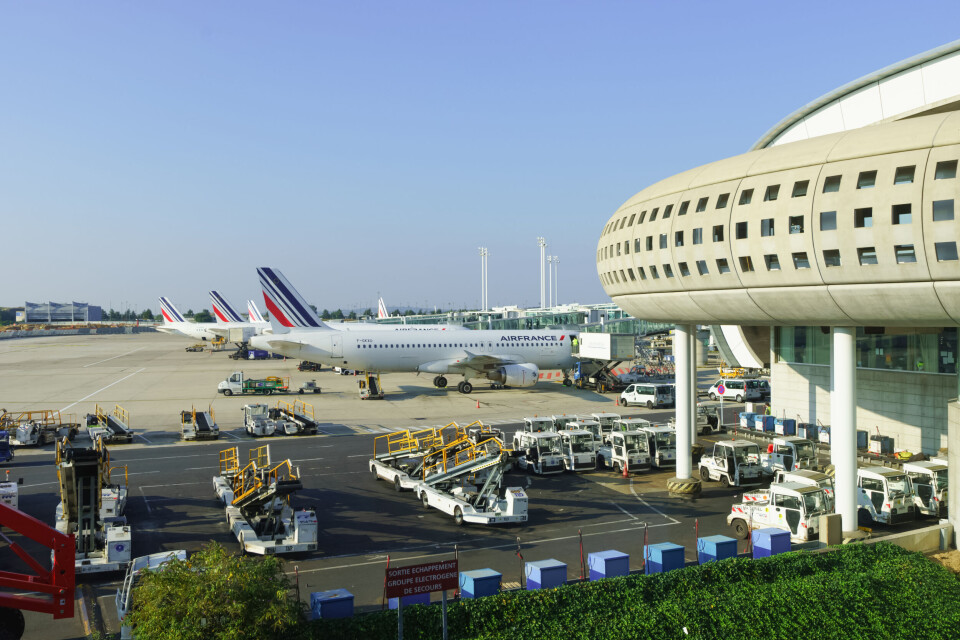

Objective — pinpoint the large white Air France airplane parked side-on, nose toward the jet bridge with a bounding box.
[250,267,576,394]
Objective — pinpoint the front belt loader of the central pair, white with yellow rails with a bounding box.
[414,440,528,525]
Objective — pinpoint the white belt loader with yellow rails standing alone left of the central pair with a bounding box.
[213,445,317,555]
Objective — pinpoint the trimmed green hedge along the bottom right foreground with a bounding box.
[307,543,960,640]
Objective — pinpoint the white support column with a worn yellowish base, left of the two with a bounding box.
[667,324,701,496]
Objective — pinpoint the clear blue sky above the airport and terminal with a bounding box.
[0,0,960,311]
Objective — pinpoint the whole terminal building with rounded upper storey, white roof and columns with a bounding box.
[596,41,960,530]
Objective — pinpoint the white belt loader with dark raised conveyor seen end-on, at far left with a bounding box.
[56,438,132,573]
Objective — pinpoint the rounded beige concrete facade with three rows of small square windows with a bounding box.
[597,112,960,326]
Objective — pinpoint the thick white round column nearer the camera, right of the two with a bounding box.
[830,327,857,532]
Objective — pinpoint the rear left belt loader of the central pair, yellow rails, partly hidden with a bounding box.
[369,428,444,492]
